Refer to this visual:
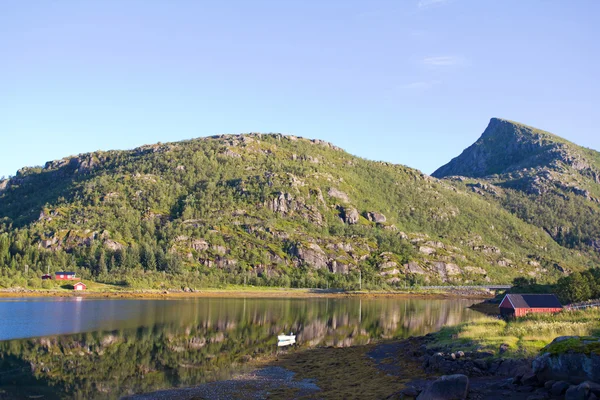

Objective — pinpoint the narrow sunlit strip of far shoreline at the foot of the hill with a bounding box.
[0,287,492,299]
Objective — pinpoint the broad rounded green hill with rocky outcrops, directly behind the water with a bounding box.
[0,131,596,288]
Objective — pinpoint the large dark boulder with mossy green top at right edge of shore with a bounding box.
[532,336,600,384]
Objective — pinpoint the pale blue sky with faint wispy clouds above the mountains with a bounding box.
[0,0,600,176]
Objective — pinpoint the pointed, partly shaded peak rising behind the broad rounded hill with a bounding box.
[433,118,600,252]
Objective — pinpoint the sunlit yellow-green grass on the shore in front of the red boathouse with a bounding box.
[432,308,600,358]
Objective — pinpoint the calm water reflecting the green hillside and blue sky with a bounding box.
[0,298,481,399]
